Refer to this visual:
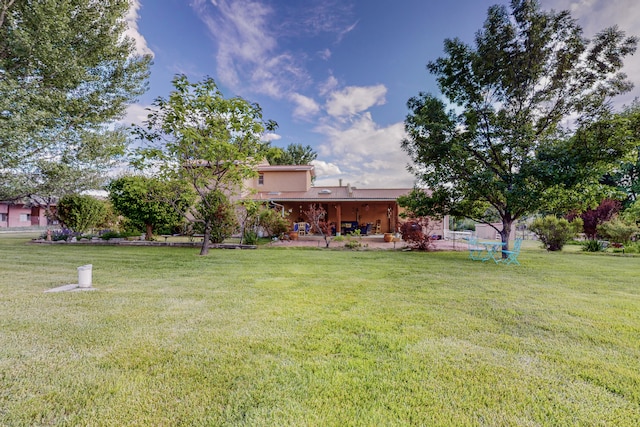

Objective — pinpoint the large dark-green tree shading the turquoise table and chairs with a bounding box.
[402,0,637,252]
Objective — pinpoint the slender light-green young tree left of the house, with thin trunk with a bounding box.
[136,75,276,255]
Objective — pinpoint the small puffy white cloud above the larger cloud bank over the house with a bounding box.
[326,85,387,117]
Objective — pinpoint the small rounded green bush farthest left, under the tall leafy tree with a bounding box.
[56,194,107,233]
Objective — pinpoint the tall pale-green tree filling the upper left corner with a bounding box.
[0,0,150,204]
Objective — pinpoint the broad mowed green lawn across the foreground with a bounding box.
[0,236,640,426]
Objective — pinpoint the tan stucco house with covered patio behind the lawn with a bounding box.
[243,164,448,236]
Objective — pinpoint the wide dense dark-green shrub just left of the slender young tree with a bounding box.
[107,176,195,240]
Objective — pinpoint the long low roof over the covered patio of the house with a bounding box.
[254,186,412,202]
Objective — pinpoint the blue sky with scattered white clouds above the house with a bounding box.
[126,0,640,188]
